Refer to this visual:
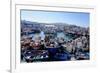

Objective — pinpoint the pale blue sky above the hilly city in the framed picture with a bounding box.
[21,10,90,27]
